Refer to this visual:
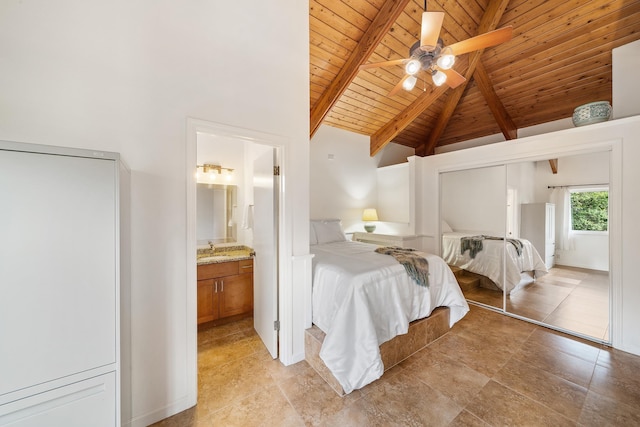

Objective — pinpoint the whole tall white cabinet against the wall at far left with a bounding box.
[0,141,120,427]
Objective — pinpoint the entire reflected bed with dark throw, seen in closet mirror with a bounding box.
[442,231,547,294]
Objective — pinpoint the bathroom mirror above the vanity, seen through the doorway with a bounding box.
[196,183,238,245]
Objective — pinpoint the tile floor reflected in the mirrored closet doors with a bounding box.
[465,266,609,341]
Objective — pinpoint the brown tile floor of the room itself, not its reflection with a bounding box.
[154,306,640,427]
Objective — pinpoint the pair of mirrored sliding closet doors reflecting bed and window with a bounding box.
[440,151,610,342]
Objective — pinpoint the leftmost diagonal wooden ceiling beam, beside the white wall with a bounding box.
[310,0,409,137]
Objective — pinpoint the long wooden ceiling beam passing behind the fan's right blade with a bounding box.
[416,0,509,156]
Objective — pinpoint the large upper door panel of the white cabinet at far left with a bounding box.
[0,148,119,402]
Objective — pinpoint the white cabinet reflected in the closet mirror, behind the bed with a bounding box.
[520,203,556,268]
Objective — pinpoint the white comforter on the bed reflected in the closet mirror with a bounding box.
[442,231,548,293]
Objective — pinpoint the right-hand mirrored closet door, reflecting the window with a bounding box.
[505,151,610,342]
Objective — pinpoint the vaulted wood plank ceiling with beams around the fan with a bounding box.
[309,0,640,156]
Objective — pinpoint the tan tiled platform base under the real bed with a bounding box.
[304,307,450,396]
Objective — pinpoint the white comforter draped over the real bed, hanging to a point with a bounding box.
[311,241,469,393]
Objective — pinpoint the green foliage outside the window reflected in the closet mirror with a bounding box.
[571,191,609,231]
